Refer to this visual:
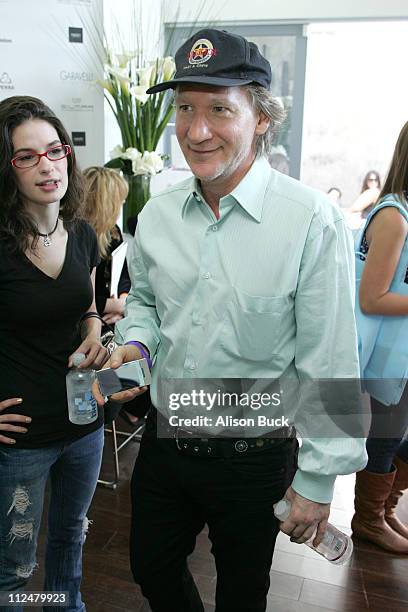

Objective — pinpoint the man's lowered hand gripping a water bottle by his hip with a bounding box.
[280,487,330,546]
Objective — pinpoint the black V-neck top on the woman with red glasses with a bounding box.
[0,221,102,448]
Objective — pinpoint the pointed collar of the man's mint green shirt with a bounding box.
[181,157,271,223]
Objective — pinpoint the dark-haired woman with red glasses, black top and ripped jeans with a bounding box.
[0,96,106,612]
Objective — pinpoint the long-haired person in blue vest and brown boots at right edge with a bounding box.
[352,122,408,554]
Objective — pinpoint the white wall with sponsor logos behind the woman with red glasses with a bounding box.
[0,0,103,167]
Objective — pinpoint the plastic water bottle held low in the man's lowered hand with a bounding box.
[273,499,353,565]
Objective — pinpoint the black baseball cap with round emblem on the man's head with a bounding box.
[147,28,272,94]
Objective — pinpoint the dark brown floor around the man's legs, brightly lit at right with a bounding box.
[27,426,408,612]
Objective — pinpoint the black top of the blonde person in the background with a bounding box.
[95,225,130,316]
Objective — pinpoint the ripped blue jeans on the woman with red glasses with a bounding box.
[0,427,103,612]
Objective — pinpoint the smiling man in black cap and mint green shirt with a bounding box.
[96,29,365,612]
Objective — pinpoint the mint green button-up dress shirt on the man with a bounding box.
[116,158,367,503]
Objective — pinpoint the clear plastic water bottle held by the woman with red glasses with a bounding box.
[67,353,98,425]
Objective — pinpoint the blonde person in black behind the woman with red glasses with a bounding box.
[83,166,150,425]
